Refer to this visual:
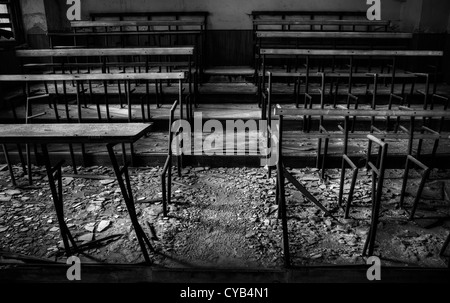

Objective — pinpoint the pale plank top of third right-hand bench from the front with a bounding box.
[256,31,413,39]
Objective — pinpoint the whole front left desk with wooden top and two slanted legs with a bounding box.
[0,123,153,263]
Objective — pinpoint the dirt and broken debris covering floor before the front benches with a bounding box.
[0,166,450,269]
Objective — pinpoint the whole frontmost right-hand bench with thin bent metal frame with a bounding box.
[268,105,450,267]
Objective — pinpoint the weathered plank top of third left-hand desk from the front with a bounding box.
[16,46,194,57]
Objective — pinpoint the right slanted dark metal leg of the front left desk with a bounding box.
[107,144,153,263]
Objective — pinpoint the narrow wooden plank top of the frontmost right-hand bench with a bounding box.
[275,106,450,118]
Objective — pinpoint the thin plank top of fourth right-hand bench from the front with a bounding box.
[253,19,391,26]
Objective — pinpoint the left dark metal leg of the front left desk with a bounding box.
[42,144,77,256]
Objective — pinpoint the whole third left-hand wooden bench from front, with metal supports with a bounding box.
[16,46,199,109]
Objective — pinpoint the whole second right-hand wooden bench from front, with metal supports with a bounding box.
[258,49,443,113]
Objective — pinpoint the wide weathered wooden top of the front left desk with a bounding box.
[0,123,153,144]
